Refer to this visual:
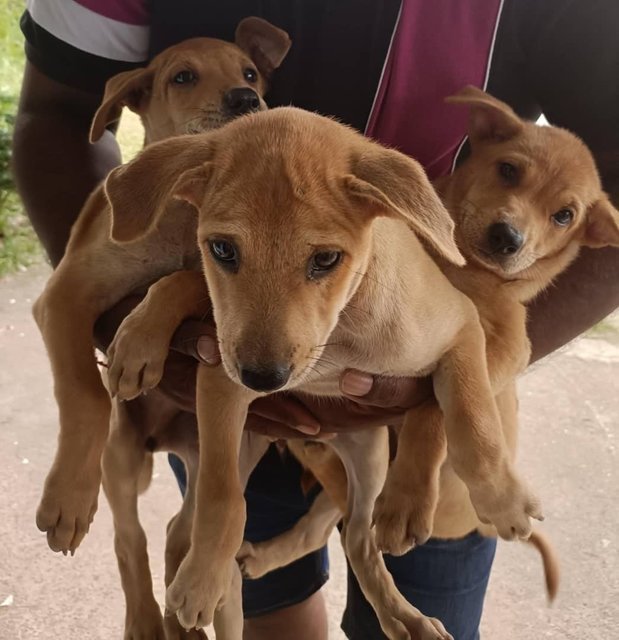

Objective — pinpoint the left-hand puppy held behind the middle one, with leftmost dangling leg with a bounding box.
[34,18,290,638]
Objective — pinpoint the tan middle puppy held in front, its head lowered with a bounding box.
[106,108,539,638]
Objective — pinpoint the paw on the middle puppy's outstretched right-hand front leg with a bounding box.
[469,468,544,540]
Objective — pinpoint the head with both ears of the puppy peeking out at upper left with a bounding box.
[91,18,290,143]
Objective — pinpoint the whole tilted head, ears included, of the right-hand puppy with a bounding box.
[447,87,619,278]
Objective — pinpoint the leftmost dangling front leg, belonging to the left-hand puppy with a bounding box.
[33,276,111,554]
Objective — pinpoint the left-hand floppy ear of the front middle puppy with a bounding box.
[104,133,213,243]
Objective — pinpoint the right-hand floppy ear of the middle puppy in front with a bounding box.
[344,143,465,265]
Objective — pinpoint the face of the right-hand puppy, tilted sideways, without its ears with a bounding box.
[454,126,602,275]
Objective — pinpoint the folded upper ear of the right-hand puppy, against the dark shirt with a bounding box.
[445,86,524,144]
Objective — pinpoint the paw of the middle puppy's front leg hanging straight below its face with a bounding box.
[166,551,231,631]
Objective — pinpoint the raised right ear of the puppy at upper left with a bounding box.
[234,16,292,79]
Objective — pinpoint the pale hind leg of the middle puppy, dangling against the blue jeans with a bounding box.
[330,428,453,640]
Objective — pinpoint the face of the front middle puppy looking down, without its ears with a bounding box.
[198,175,371,391]
